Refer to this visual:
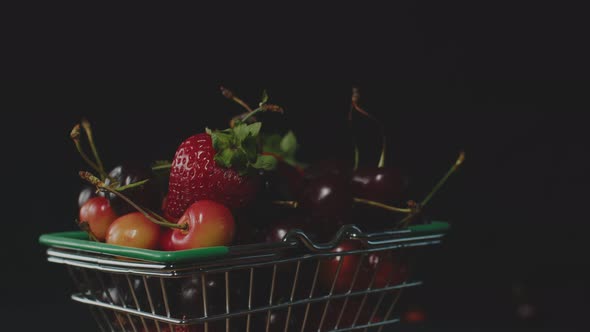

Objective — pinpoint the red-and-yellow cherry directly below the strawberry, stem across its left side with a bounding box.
[171,200,235,250]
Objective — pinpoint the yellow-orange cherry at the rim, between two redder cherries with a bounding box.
[106,212,161,249]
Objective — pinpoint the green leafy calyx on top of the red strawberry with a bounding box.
[206,122,277,175]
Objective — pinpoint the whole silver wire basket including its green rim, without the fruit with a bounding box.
[40,222,448,332]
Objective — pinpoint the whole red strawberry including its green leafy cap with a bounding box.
[164,109,276,218]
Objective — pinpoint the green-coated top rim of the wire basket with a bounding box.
[39,221,450,264]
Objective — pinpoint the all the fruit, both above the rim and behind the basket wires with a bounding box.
[70,88,464,331]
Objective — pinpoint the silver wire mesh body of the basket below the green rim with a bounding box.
[48,226,440,332]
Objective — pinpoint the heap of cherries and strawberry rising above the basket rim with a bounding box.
[70,88,464,268]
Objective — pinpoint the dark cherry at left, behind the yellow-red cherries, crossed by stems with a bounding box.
[101,162,162,215]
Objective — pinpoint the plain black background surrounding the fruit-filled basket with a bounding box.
[0,3,590,331]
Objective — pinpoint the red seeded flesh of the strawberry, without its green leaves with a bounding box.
[165,133,260,218]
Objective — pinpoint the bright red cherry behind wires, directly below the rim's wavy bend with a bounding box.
[320,240,368,293]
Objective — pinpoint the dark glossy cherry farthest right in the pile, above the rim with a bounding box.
[351,167,406,203]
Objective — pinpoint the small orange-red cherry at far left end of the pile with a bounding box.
[79,197,118,241]
